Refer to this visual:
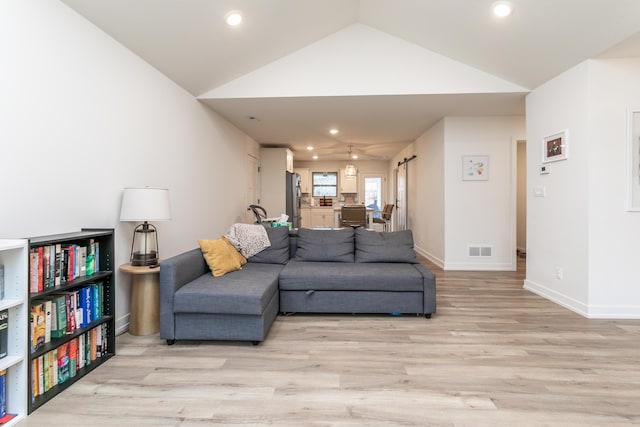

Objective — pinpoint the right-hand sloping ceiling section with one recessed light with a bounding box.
[358,0,640,89]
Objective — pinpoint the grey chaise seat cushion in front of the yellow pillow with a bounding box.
[173,263,283,315]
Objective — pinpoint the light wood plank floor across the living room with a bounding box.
[19,262,640,427]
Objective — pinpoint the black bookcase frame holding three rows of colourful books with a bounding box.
[26,228,116,413]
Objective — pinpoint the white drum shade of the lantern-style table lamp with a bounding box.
[120,187,171,222]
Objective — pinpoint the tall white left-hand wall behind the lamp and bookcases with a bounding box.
[0,0,256,330]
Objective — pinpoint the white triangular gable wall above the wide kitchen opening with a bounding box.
[199,24,528,99]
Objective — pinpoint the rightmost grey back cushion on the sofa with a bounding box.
[355,228,418,264]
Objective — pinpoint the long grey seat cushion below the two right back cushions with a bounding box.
[279,259,423,292]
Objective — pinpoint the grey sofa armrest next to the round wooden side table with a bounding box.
[160,248,209,340]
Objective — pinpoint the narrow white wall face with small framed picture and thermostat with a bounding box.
[525,63,590,314]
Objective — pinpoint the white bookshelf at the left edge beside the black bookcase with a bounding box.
[0,239,29,427]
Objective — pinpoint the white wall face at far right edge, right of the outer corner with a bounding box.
[587,58,640,318]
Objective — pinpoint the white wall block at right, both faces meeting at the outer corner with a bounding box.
[525,58,640,318]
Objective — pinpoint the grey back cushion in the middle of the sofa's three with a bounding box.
[296,227,354,262]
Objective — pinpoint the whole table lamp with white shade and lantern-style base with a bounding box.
[120,187,171,267]
